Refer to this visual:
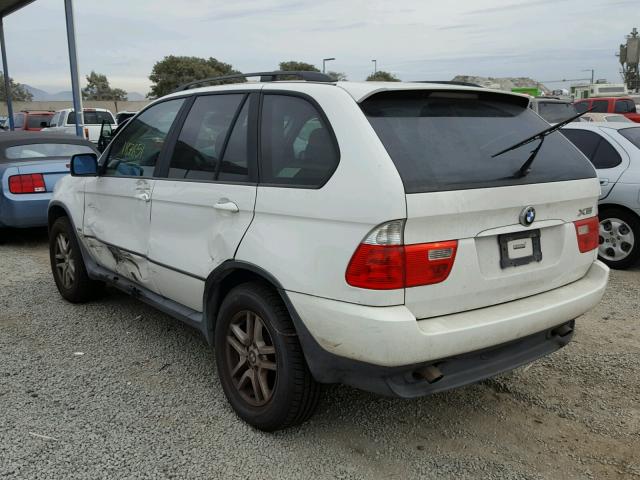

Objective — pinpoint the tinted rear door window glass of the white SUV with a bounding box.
[169,94,248,181]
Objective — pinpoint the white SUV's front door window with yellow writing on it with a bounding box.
[104,98,184,177]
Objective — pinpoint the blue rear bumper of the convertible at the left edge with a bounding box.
[0,192,52,228]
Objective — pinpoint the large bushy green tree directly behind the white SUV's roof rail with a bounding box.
[147,55,243,98]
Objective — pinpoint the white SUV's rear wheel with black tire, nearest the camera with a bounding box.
[215,282,320,432]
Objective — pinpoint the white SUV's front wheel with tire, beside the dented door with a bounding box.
[49,217,104,303]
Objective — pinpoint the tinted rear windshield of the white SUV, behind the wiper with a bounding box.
[361,90,595,193]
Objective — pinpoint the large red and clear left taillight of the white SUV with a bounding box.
[345,220,458,290]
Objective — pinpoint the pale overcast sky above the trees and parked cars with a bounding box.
[4,0,640,94]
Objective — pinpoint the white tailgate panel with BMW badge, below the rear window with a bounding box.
[405,178,600,319]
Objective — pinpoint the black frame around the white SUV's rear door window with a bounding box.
[154,88,259,187]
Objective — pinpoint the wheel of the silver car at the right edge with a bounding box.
[598,207,640,270]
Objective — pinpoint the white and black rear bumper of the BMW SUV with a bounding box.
[287,261,609,396]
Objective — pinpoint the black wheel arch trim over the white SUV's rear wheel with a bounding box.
[203,260,295,344]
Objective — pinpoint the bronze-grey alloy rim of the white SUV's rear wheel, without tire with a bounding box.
[226,310,278,407]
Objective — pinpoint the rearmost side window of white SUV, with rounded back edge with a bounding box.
[261,95,339,187]
